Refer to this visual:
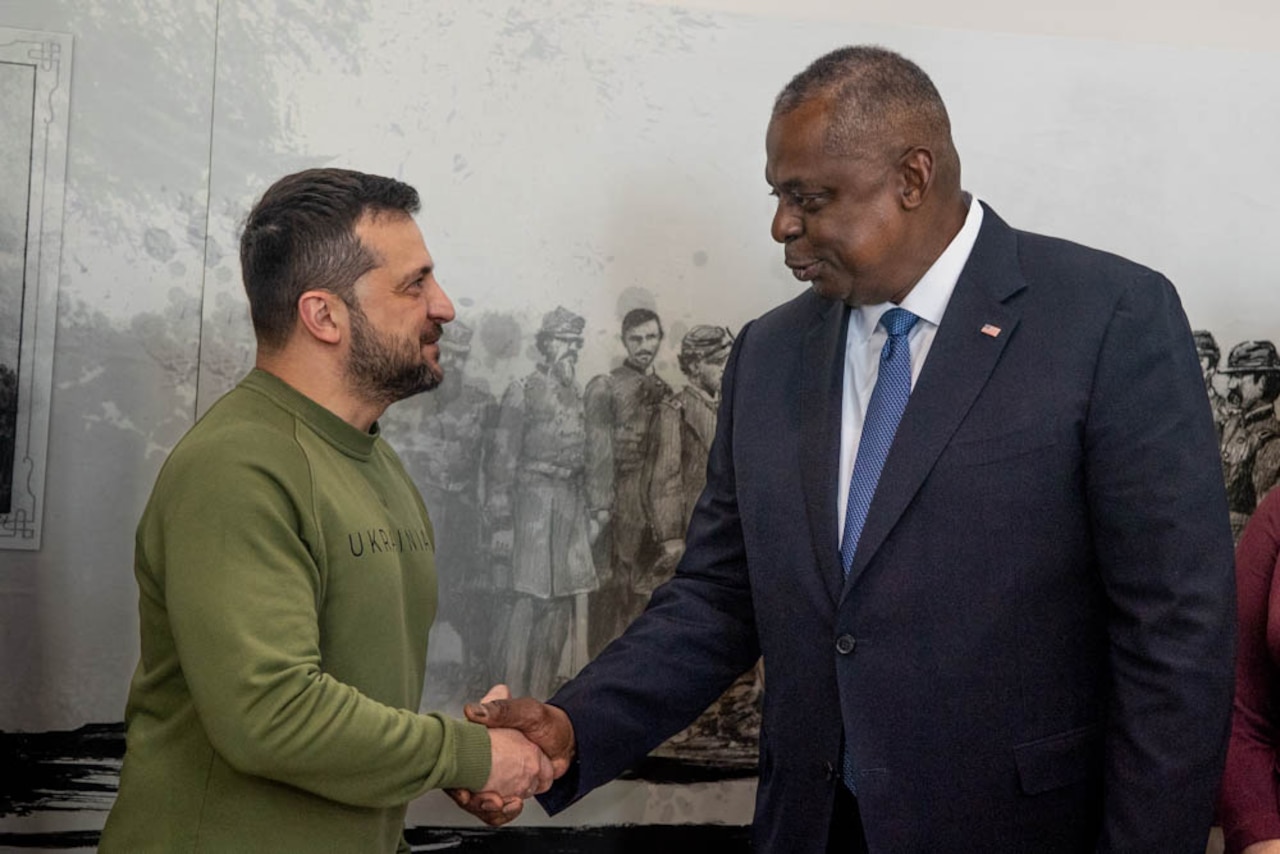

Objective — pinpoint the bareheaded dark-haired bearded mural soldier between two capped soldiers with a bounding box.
[585,309,678,657]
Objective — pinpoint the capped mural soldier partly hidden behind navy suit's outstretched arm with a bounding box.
[645,325,764,762]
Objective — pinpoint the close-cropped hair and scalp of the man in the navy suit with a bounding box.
[773,45,960,192]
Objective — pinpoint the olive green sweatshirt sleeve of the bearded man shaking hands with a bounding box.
[138,440,490,807]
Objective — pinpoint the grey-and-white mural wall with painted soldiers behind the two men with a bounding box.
[0,0,1280,851]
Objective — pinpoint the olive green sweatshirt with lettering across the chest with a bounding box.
[99,370,490,854]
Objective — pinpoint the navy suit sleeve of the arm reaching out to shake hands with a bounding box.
[539,324,760,814]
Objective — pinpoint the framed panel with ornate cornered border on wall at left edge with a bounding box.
[0,27,72,549]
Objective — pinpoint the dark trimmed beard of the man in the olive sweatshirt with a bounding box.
[347,303,443,406]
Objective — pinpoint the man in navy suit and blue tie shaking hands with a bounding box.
[455,47,1234,854]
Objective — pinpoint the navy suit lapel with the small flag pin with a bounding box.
[842,207,1027,595]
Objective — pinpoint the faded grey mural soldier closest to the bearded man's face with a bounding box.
[402,320,503,695]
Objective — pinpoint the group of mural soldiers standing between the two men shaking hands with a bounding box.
[383,306,763,777]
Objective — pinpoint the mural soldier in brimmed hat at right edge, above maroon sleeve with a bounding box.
[1222,341,1280,539]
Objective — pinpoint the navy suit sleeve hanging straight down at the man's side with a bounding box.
[1084,271,1235,854]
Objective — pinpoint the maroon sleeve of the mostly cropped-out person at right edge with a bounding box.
[1219,492,1280,854]
